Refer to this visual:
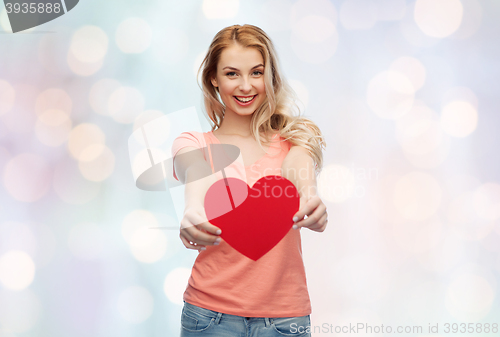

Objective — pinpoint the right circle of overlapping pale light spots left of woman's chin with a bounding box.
[108,87,144,124]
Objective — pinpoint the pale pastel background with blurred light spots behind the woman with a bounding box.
[0,0,500,337]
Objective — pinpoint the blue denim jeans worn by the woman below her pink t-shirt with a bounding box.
[181,302,311,337]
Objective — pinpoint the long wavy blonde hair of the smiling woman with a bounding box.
[198,24,326,174]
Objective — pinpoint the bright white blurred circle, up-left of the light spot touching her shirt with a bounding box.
[129,226,167,263]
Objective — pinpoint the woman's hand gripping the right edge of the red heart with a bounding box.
[293,195,328,232]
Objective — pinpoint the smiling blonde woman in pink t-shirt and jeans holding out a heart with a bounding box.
[172,25,327,337]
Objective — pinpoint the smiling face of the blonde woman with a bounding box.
[212,44,266,115]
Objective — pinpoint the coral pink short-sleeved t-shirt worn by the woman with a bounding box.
[172,132,311,317]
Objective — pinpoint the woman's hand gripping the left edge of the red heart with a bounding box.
[179,208,222,251]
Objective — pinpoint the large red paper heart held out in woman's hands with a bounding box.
[204,175,300,261]
